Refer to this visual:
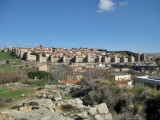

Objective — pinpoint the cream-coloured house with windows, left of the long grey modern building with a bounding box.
[111,73,132,81]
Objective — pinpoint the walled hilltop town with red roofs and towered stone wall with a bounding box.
[5,45,146,63]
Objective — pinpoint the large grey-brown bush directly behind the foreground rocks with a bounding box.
[72,81,121,110]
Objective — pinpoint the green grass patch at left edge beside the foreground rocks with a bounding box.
[0,87,34,99]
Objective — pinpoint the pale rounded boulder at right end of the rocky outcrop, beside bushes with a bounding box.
[96,103,109,114]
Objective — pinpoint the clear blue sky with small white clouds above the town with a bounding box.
[0,0,160,53]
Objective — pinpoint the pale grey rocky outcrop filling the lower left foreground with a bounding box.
[0,84,112,120]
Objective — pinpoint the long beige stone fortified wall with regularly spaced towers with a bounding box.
[9,48,146,63]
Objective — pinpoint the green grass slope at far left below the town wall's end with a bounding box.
[0,52,14,61]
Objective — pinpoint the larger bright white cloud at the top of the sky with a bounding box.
[97,0,116,13]
